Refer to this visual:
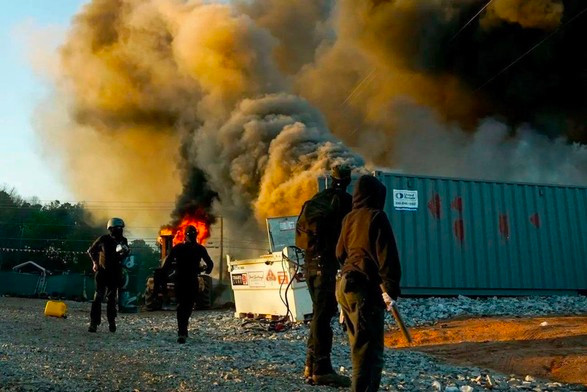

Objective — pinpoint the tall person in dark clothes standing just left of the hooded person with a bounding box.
[296,165,352,387]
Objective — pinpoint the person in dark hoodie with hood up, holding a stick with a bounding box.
[336,175,401,391]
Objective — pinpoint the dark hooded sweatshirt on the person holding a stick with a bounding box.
[336,175,401,298]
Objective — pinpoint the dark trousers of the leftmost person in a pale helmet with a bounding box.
[90,268,122,325]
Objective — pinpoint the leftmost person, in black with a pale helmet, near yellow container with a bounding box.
[88,218,130,332]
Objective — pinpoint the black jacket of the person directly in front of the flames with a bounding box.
[163,242,214,286]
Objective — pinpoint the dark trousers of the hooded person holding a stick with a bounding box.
[336,272,385,392]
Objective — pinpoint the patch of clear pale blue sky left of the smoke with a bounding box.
[0,0,87,201]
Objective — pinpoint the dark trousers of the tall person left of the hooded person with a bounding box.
[306,272,337,375]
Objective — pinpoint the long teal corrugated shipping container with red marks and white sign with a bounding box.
[319,171,587,295]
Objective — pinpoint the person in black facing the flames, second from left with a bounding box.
[163,225,214,344]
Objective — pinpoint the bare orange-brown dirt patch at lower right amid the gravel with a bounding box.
[385,316,587,385]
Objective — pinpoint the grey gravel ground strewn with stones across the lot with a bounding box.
[0,297,587,392]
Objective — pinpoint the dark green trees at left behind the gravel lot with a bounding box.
[0,187,159,273]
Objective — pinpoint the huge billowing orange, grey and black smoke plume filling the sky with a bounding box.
[39,0,587,247]
